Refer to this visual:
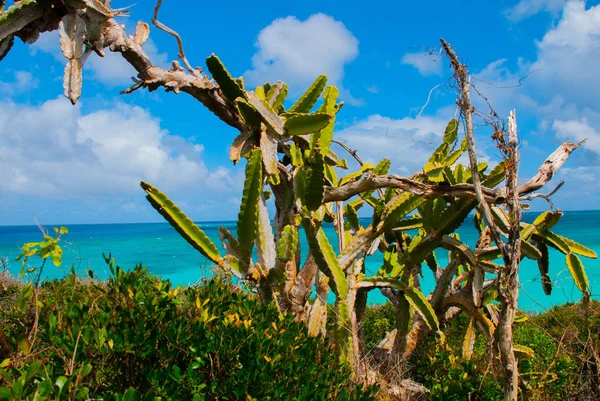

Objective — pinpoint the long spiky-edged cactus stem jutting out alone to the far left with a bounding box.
[140,181,221,263]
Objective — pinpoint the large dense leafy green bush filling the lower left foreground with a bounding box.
[0,262,373,400]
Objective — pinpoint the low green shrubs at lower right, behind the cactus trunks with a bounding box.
[364,301,600,401]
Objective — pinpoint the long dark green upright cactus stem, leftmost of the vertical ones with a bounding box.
[237,149,262,262]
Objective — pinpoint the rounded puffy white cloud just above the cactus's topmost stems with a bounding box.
[244,13,358,95]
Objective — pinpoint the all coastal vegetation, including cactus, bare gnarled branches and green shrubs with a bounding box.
[0,0,598,400]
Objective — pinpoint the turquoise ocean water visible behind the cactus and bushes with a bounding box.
[0,211,600,311]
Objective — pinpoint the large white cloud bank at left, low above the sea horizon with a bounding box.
[0,98,239,197]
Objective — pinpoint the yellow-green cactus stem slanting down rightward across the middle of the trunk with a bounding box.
[302,217,348,296]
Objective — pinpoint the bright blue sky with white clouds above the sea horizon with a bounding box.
[0,0,600,225]
